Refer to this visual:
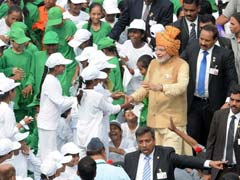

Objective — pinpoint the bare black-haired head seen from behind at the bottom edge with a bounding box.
[78,156,97,180]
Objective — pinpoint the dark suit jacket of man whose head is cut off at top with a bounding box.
[109,0,173,40]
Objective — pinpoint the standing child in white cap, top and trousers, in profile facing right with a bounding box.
[37,53,76,161]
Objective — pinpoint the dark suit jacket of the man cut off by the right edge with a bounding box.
[206,108,240,180]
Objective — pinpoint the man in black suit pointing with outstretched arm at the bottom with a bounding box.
[124,127,223,180]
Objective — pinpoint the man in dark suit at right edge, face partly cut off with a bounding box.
[203,85,240,180]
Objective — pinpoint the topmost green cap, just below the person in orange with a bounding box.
[47,7,63,26]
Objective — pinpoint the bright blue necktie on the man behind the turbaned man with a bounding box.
[197,51,208,96]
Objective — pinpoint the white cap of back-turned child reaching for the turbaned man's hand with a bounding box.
[81,65,107,81]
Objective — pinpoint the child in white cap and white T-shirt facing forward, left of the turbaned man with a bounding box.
[119,19,152,94]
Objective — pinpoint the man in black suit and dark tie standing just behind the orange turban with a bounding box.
[173,0,201,53]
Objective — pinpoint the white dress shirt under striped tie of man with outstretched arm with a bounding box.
[136,149,155,180]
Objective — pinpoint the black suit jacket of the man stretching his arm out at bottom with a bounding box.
[124,146,205,180]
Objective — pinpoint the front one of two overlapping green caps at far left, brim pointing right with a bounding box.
[9,28,30,44]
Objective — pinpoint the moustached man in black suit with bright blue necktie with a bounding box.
[181,24,237,146]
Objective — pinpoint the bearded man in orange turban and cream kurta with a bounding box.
[127,26,191,154]
